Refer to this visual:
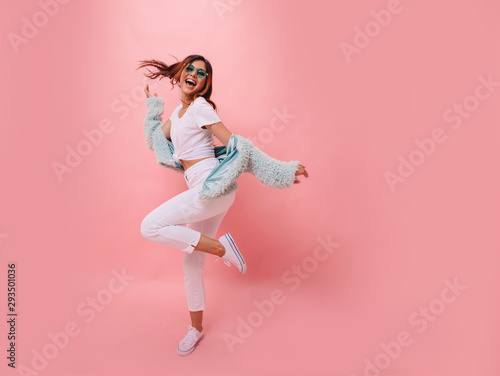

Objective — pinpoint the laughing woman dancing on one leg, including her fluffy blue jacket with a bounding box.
[138,55,308,355]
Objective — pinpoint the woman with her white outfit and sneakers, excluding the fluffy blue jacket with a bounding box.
[138,55,308,355]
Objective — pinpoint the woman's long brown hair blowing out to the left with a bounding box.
[136,55,217,110]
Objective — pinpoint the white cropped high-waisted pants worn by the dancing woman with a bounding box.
[141,157,236,312]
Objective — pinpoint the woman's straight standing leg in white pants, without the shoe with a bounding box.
[183,209,229,332]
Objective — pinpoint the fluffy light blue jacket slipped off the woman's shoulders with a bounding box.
[144,97,299,200]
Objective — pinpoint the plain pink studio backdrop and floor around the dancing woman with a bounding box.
[0,0,500,376]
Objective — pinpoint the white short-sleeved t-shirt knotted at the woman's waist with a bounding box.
[170,97,221,162]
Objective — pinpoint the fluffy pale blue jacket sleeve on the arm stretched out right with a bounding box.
[245,139,299,189]
